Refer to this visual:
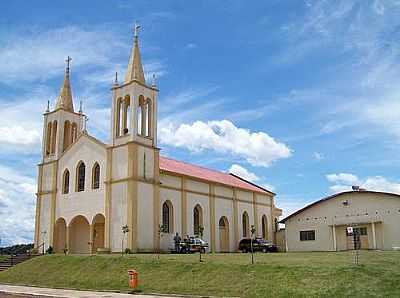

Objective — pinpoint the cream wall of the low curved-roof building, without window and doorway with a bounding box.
[285,192,400,251]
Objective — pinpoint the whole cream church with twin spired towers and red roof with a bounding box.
[35,28,281,253]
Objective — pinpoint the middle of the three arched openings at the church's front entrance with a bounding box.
[69,215,90,254]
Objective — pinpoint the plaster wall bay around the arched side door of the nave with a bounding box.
[215,197,237,252]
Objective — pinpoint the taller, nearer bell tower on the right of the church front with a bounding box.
[106,24,160,252]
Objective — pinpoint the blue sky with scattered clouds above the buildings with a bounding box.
[0,0,400,245]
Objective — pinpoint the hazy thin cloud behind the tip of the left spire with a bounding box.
[0,26,128,82]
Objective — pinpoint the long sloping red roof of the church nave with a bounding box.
[160,156,274,194]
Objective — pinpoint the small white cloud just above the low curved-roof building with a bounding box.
[326,173,400,194]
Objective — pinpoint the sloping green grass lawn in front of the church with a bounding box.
[0,251,400,297]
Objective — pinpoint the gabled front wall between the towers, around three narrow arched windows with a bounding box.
[55,137,106,225]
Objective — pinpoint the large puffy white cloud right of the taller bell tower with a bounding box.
[159,120,291,167]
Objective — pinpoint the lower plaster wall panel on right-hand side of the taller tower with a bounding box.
[137,182,154,250]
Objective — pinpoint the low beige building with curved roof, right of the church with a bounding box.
[281,190,400,251]
